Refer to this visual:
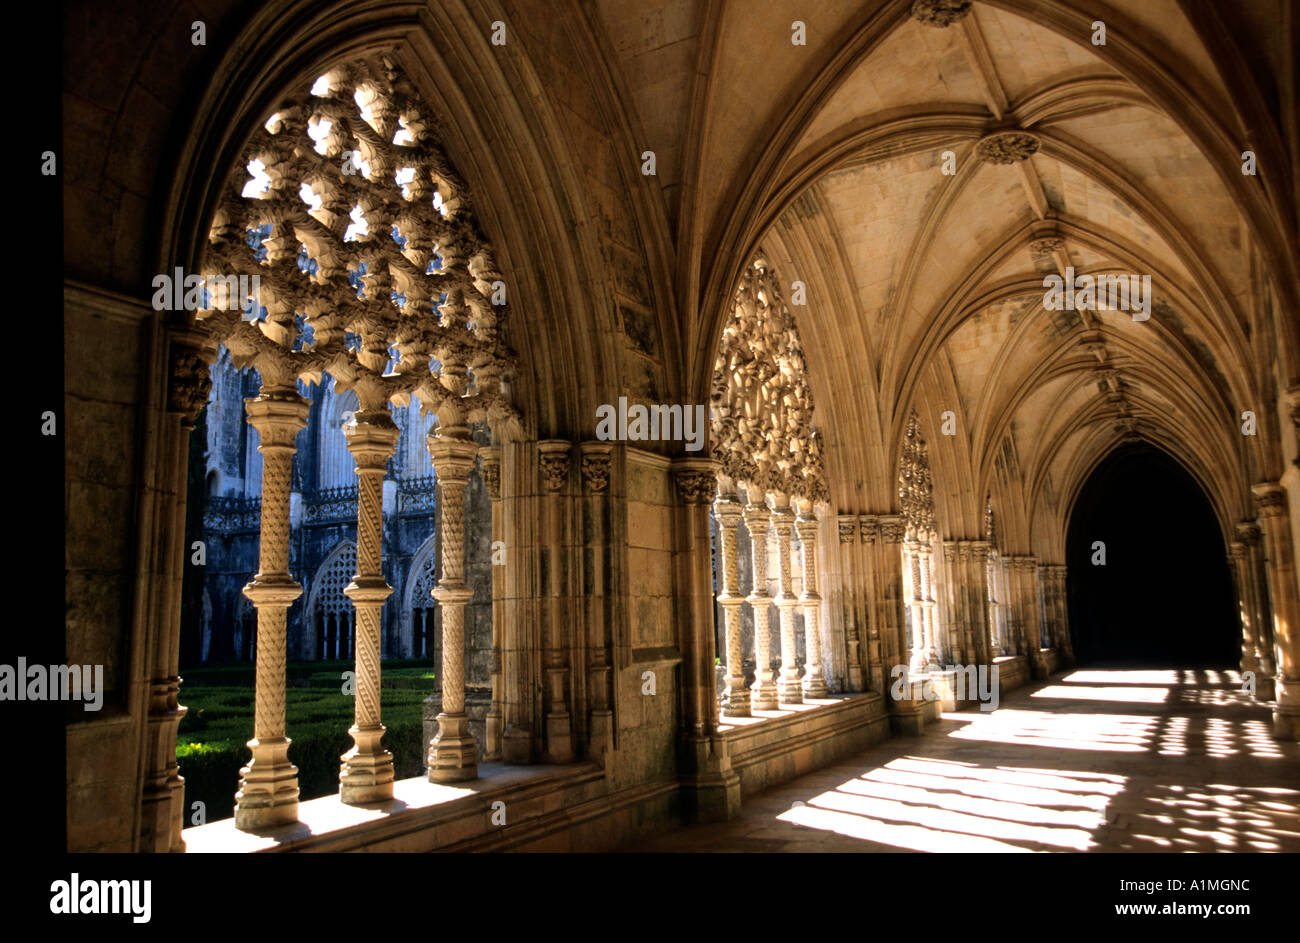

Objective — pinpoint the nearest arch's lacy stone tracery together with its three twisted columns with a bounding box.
[199,61,515,829]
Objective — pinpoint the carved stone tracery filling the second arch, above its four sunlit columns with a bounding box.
[711,252,829,501]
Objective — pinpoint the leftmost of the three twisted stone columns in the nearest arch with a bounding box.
[235,384,308,830]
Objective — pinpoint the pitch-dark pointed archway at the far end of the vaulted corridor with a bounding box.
[1066,444,1240,667]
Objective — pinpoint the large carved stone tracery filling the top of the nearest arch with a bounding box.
[199,56,516,426]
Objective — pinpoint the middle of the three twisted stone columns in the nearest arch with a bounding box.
[338,407,400,805]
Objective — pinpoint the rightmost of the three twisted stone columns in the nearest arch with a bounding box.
[428,427,478,783]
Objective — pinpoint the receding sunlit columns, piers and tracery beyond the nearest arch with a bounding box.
[712,252,1074,717]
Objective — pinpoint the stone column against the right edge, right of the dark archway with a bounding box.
[1251,481,1300,740]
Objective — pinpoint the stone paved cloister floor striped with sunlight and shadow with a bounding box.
[627,670,1300,852]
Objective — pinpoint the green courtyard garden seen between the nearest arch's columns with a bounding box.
[176,662,434,826]
